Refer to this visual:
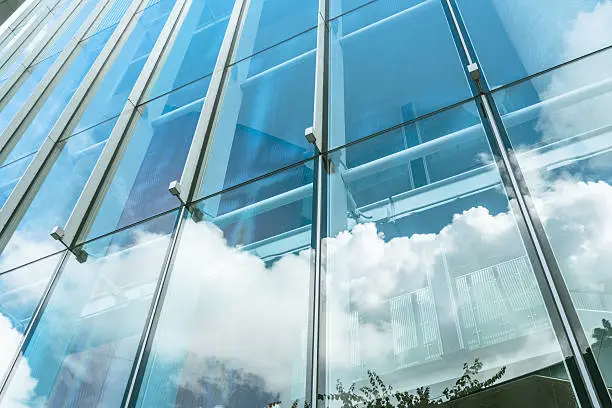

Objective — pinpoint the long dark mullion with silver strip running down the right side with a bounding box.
[445,0,612,407]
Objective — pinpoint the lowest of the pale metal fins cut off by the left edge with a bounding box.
[0,0,146,252]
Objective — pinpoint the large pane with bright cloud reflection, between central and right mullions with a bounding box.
[322,102,577,407]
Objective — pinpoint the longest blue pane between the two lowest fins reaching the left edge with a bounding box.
[3,27,115,170]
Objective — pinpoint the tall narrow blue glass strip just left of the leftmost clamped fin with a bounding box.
[0,0,175,269]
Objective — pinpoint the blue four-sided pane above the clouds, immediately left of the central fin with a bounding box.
[200,29,316,197]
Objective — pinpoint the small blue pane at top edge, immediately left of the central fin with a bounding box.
[233,0,319,62]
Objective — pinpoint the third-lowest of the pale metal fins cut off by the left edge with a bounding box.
[0,0,84,109]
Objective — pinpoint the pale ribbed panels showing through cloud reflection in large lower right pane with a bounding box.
[348,256,551,377]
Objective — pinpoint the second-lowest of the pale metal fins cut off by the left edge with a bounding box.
[0,0,114,163]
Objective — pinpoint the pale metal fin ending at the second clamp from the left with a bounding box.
[168,0,250,206]
